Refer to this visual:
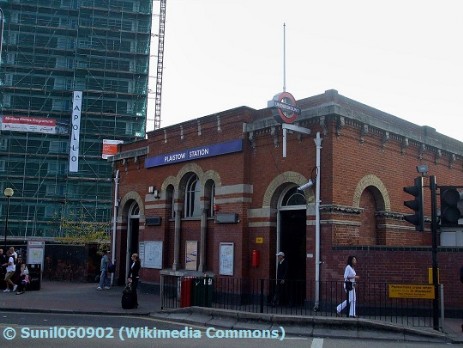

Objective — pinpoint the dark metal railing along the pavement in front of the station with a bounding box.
[161,275,433,328]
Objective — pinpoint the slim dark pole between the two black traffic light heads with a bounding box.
[429,175,439,330]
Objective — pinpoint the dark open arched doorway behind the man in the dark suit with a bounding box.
[277,187,307,305]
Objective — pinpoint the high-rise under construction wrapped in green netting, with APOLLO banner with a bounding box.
[0,0,156,244]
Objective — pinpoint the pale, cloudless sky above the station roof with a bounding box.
[147,0,463,141]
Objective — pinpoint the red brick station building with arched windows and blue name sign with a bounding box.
[112,90,463,309]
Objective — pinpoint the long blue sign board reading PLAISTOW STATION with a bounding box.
[145,139,243,168]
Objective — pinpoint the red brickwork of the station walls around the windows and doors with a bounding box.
[113,96,463,306]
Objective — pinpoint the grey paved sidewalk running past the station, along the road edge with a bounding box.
[0,281,463,344]
